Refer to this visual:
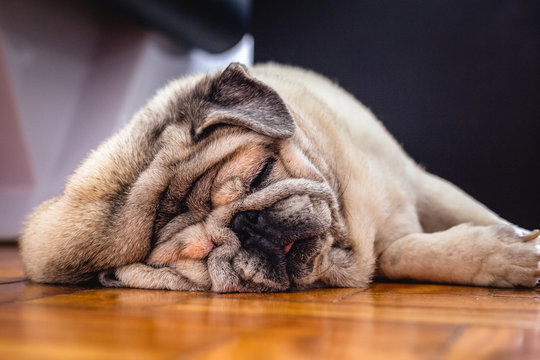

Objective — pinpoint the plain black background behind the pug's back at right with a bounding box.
[251,0,540,228]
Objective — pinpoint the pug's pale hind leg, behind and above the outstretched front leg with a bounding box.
[415,172,508,232]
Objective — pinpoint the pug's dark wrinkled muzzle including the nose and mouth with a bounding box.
[223,195,332,291]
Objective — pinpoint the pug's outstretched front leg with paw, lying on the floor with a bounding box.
[378,224,540,287]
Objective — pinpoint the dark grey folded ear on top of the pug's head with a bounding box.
[195,63,295,139]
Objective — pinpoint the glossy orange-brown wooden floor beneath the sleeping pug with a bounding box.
[0,245,540,359]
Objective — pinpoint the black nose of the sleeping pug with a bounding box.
[230,210,283,255]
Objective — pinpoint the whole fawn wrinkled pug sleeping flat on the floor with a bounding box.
[20,63,540,292]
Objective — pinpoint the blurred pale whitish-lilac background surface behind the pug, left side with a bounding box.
[0,0,253,239]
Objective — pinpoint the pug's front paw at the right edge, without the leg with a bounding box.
[472,225,540,287]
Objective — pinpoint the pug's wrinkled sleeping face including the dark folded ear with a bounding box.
[139,64,344,292]
